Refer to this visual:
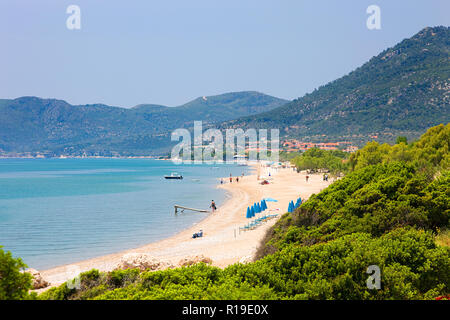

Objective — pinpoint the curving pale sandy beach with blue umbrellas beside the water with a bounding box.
[40,168,331,291]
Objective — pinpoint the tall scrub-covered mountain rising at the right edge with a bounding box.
[221,27,450,144]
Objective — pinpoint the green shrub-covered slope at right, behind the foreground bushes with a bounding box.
[261,124,450,254]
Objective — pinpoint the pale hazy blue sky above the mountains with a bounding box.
[0,0,450,108]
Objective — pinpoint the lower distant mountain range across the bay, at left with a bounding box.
[0,91,287,156]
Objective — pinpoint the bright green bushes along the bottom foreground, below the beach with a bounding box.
[39,229,450,300]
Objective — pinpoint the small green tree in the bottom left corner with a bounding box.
[0,246,31,300]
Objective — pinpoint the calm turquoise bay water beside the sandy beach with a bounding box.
[0,159,248,269]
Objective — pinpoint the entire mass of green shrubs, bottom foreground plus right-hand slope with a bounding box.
[29,124,450,299]
